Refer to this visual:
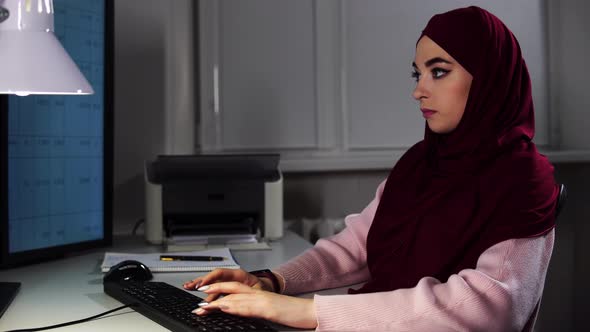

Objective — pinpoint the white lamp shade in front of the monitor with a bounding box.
[0,0,94,95]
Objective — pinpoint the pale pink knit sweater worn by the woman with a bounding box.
[274,182,554,331]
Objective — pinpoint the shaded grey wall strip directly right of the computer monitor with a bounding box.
[113,0,166,234]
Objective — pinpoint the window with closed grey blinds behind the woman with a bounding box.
[200,0,549,171]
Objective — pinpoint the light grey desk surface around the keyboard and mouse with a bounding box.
[0,232,311,332]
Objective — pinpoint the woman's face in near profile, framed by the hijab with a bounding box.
[412,36,473,134]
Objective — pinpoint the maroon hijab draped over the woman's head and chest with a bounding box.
[350,7,558,293]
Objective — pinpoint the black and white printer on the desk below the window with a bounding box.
[145,154,283,245]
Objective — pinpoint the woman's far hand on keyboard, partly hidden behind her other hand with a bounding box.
[183,269,275,302]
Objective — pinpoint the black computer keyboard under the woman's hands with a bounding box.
[104,281,276,332]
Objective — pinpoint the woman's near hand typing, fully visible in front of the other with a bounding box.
[193,281,317,329]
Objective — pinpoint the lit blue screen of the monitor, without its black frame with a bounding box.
[8,0,105,253]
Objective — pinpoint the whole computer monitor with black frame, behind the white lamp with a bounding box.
[0,0,114,267]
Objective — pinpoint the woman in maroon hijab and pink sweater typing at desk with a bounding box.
[184,7,558,331]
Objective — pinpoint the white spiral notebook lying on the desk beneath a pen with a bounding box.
[100,248,240,272]
